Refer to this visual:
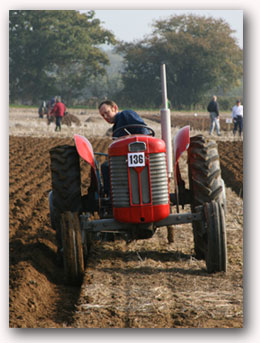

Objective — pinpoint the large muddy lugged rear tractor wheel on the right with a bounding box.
[188,135,225,259]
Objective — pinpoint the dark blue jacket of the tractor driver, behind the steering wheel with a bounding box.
[113,110,149,137]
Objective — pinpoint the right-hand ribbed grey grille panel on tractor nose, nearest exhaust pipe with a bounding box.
[150,153,169,205]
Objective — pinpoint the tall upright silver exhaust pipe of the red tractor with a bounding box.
[160,64,173,178]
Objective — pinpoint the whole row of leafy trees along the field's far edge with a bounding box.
[9,10,243,109]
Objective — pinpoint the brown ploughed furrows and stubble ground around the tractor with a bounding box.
[9,109,243,328]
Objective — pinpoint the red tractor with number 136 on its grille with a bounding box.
[49,126,227,284]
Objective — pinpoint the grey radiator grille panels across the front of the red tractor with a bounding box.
[110,153,169,207]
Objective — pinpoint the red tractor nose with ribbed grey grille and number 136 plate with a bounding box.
[108,135,170,224]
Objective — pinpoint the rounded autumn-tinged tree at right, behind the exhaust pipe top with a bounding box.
[117,15,243,108]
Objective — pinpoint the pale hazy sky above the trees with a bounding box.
[90,9,243,48]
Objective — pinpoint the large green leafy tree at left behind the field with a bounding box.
[9,10,116,102]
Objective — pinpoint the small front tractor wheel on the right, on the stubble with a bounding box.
[203,201,227,273]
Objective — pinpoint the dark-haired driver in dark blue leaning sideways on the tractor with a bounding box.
[98,100,149,196]
